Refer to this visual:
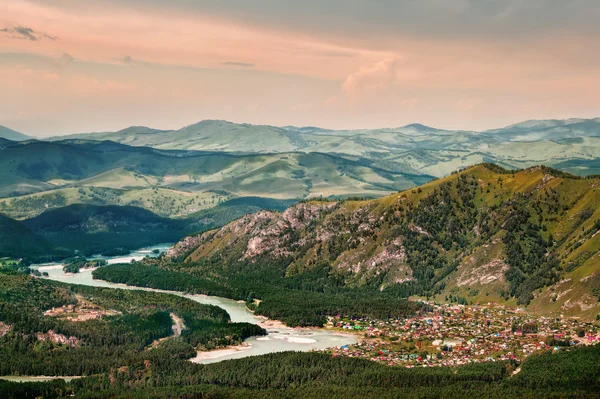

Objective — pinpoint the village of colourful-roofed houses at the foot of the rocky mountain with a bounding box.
[328,304,600,368]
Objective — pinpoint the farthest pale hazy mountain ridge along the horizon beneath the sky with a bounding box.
[45,118,600,177]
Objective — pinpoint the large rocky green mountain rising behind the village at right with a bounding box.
[170,164,600,318]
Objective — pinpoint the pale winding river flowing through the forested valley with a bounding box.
[32,244,356,364]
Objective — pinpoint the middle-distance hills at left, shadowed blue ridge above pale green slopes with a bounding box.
[0,140,431,218]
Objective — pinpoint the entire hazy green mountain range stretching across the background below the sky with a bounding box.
[0,118,600,218]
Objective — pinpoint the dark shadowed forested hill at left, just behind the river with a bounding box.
[0,204,192,262]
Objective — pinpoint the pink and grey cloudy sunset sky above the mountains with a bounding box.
[0,0,600,137]
